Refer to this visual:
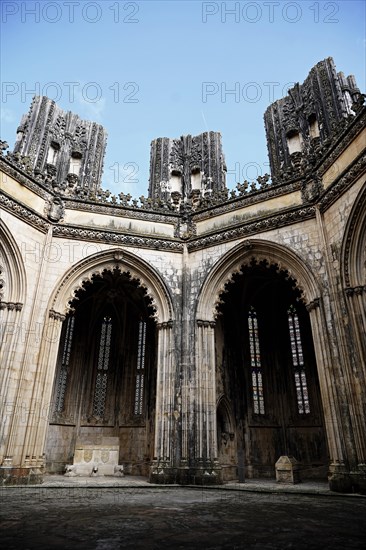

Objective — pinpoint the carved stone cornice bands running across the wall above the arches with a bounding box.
[0,108,366,252]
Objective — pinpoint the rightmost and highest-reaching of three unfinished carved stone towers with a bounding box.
[264,57,360,182]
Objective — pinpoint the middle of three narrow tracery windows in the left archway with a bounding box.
[93,316,112,418]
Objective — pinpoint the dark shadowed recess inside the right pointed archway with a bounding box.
[215,257,328,479]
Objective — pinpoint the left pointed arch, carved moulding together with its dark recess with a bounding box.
[44,249,174,475]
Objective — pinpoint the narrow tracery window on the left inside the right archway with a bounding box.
[248,307,265,414]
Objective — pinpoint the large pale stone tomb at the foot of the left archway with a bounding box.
[65,437,124,477]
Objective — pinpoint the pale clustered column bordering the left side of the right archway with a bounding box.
[191,320,221,484]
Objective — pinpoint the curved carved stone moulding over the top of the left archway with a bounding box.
[49,249,174,323]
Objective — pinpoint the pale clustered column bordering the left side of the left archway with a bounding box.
[0,311,65,484]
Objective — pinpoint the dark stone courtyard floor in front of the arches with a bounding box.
[0,476,366,550]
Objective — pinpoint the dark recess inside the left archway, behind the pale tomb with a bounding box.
[46,266,157,475]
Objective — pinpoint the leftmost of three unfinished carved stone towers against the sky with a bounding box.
[14,96,106,196]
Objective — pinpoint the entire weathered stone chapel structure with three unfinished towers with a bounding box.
[0,59,366,492]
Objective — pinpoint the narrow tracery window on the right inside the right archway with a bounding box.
[287,306,310,414]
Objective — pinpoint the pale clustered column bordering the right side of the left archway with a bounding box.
[150,321,179,483]
